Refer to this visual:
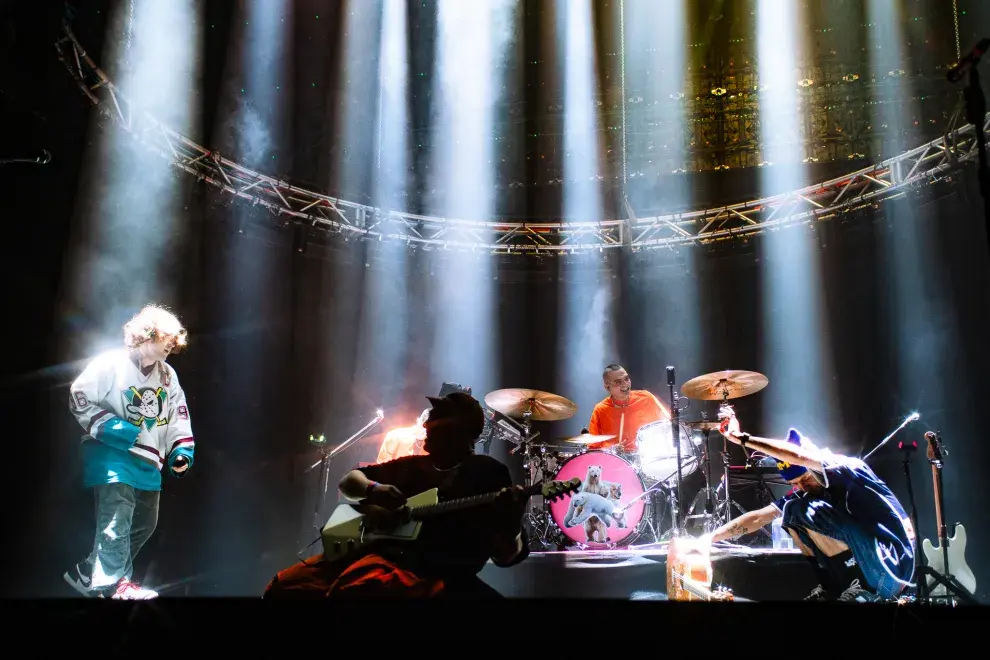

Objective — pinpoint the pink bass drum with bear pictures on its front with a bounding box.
[549,451,650,548]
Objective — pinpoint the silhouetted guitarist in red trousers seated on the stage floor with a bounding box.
[264,392,529,598]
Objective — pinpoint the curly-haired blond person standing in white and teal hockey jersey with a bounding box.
[64,305,195,600]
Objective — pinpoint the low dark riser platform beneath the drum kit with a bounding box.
[481,544,817,602]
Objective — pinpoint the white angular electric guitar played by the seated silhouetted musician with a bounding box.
[321,477,581,562]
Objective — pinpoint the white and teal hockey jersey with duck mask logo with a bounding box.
[69,349,195,490]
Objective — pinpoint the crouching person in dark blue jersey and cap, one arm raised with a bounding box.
[707,415,914,602]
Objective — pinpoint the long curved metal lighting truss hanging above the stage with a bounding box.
[55,24,990,255]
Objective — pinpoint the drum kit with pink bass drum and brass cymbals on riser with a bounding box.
[485,369,769,550]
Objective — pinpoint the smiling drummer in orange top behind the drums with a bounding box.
[587,364,670,453]
